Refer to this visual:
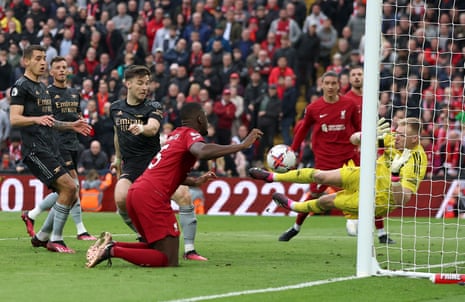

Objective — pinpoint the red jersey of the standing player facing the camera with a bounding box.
[291,96,360,170]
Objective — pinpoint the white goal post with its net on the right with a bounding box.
[356,0,465,283]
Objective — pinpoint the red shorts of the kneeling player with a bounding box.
[126,188,179,244]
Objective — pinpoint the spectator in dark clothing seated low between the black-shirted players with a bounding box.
[78,140,109,174]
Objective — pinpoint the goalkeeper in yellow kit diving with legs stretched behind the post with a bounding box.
[249,118,427,216]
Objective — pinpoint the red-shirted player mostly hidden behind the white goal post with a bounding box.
[344,66,395,244]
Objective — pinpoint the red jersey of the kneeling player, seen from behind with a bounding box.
[131,127,204,202]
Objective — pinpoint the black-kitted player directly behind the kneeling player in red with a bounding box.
[110,65,208,261]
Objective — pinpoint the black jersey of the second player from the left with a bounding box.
[47,85,81,151]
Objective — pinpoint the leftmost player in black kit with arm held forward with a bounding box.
[10,45,91,253]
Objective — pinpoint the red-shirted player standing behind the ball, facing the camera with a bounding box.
[279,71,361,241]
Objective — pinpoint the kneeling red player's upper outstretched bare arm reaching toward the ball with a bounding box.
[189,129,263,159]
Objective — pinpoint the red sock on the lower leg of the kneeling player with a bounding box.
[112,246,168,267]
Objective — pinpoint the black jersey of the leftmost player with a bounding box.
[10,76,58,156]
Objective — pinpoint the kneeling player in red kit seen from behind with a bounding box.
[86,103,263,267]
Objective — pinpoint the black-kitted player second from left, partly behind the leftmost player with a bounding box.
[21,56,97,240]
